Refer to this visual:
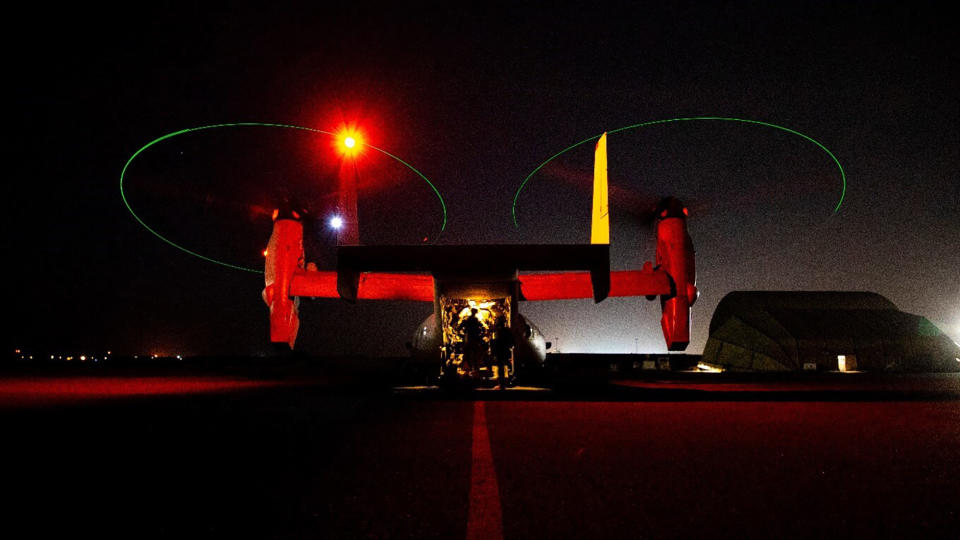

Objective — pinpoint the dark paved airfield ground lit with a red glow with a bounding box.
[0,366,960,538]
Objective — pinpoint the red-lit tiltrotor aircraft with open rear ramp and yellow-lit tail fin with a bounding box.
[263,135,698,383]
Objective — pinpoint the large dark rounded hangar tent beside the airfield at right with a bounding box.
[703,291,960,371]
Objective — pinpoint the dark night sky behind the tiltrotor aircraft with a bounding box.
[4,2,960,355]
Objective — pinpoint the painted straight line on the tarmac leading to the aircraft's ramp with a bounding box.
[467,401,503,540]
